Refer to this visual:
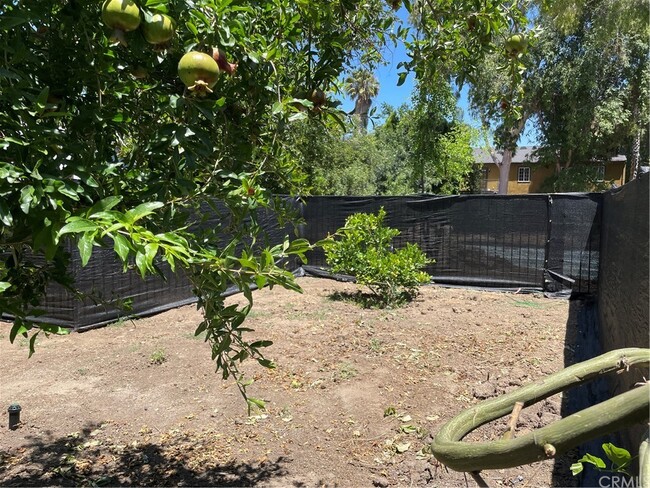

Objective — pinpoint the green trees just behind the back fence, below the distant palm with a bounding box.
[292,84,477,195]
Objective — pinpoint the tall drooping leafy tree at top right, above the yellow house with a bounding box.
[537,0,650,181]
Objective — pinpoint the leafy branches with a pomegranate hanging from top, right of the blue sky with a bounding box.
[404,0,536,121]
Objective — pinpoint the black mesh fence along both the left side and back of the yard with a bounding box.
[8,194,602,329]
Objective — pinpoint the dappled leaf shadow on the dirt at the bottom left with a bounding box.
[0,424,289,486]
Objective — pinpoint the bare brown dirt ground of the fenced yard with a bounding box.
[0,278,572,487]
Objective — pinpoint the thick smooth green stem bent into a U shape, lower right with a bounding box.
[431,348,650,471]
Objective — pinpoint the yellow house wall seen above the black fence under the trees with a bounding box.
[483,162,625,195]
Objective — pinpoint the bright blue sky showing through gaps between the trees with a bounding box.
[334,8,536,146]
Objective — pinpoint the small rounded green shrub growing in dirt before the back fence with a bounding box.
[323,207,433,306]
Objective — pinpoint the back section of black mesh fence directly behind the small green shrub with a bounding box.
[302,194,602,294]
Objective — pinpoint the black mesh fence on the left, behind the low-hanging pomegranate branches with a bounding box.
[12,199,299,330]
